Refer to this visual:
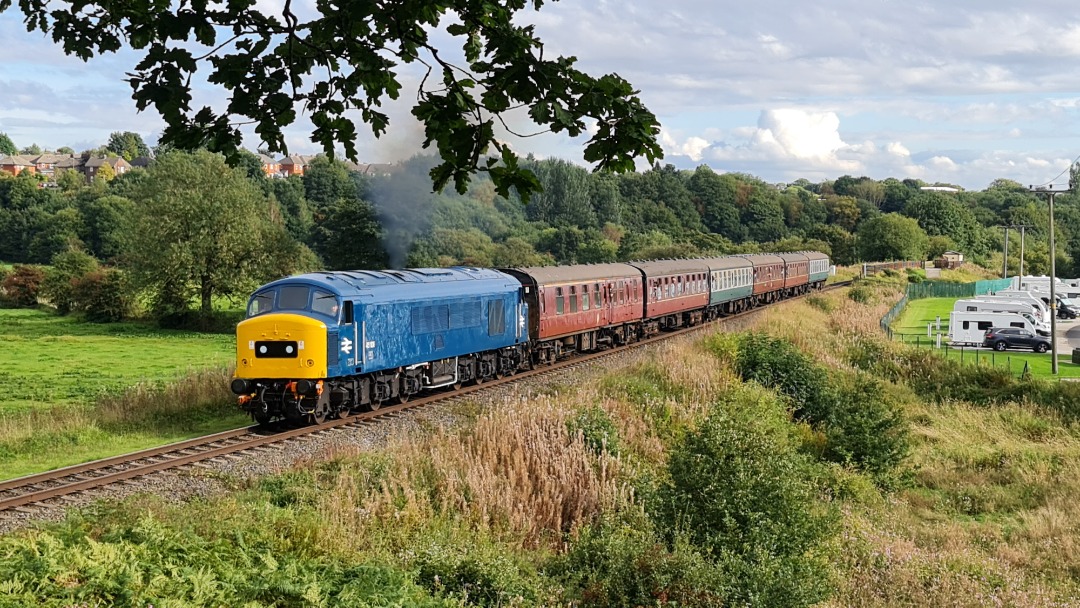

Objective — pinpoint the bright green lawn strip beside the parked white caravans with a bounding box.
[892,298,1080,378]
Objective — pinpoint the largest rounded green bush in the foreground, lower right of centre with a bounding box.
[658,392,838,606]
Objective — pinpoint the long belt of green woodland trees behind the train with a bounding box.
[0,146,1080,324]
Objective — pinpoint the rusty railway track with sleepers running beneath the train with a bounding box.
[0,281,851,513]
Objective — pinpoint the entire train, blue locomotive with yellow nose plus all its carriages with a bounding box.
[231,252,829,423]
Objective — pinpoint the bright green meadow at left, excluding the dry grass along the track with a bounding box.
[0,310,234,414]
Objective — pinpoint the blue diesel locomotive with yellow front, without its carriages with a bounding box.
[232,268,529,422]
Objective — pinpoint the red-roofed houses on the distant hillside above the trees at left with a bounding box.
[0,153,394,181]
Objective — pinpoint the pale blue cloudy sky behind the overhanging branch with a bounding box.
[0,0,1080,190]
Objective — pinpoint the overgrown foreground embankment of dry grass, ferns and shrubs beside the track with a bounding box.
[0,278,1080,608]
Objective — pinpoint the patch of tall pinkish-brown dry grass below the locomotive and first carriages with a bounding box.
[321,392,633,549]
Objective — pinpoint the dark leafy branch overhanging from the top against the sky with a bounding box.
[0,0,663,195]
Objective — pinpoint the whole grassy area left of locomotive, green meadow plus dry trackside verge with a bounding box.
[0,310,247,478]
